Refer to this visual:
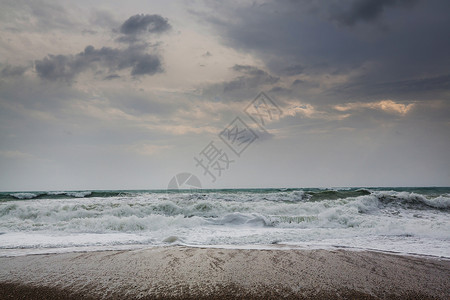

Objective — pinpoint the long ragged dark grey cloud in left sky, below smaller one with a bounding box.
[35,45,163,81]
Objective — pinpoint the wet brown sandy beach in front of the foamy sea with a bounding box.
[0,247,450,299]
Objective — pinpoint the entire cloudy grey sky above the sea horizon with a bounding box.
[0,0,450,191]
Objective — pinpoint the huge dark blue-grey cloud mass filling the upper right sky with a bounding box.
[195,0,450,102]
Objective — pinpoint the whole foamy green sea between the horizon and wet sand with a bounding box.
[0,187,450,258]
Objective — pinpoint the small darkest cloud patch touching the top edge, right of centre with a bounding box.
[332,0,417,26]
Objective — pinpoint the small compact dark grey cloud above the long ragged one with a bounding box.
[120,14,170,35]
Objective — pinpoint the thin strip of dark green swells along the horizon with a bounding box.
[0,188,450,209]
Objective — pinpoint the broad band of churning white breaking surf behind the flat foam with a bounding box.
[0,191,450,233]
